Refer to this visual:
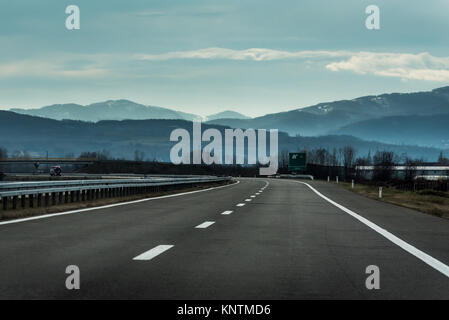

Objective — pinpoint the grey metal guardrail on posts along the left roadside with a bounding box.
[0,176,231,210]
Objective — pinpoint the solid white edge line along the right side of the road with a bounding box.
[295,181,449,277]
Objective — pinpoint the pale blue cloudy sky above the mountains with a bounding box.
[0,0,449,116]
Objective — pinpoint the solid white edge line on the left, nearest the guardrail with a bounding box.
[0,181,240,226]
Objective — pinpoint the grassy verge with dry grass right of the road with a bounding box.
[341,183,449,219]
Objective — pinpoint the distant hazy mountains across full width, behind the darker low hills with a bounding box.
[2,86,449,153]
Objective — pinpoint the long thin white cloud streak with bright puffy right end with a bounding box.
[136,48,449,82]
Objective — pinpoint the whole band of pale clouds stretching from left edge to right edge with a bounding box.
[0,48,449,82]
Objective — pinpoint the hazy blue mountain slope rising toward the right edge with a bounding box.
[209,87,449,147]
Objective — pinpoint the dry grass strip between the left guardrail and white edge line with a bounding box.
[0,182,233,220]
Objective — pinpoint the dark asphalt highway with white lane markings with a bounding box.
[0,179,449,299]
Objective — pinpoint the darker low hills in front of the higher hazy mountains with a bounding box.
[0,111,441,161]
